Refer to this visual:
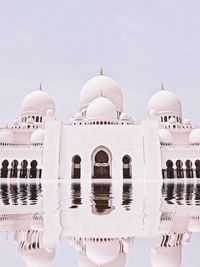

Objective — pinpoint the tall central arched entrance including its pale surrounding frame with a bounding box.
[92,147,111,179]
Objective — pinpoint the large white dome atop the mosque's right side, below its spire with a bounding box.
[147,89,182,115]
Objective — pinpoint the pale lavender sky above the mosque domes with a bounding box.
[0,0,200,126]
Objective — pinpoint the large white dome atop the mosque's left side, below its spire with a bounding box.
[21,90,55,115]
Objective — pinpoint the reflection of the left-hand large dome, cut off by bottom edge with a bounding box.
[20,249,55,267]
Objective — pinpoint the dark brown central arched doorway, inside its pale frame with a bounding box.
[93,150,110,179]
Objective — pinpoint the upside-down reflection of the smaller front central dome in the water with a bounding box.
[86,240,120,266]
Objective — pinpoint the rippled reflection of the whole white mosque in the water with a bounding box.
[0,181,200,267]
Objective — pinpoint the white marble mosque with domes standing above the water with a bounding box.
[0,70,200,180]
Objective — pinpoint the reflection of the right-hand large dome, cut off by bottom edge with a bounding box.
[151,246,181,267]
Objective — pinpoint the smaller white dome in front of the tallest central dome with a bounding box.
[86,96,117,121]
